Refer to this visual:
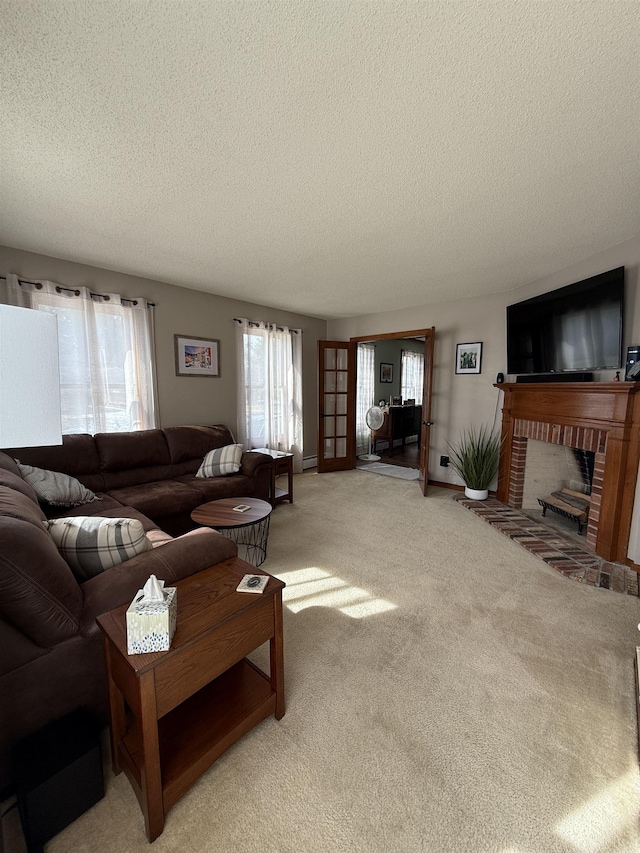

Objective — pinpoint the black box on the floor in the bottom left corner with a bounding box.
[14,709,104,853]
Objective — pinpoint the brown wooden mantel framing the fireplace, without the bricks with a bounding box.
[495,382,640,568]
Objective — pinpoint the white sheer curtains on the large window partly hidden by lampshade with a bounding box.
[7,275,156,434]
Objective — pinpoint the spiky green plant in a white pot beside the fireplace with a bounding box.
[447,426,502,501]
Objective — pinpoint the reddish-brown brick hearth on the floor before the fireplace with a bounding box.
[456,495,639,597]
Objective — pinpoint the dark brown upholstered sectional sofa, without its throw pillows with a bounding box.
[0,425,273,792]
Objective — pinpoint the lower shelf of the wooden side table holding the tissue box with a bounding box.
[118,658,276,814]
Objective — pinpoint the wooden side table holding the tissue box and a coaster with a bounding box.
[97,558,285,841]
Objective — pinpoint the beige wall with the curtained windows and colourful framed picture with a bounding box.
[0,247,326,456]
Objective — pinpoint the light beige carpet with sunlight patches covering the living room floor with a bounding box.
[23,471,640,853]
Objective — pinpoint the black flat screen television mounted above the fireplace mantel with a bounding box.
[507,267,624,374]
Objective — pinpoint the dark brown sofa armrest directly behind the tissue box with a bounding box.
[80,527,238,629]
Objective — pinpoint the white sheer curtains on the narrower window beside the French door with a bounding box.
[236,318,302,473]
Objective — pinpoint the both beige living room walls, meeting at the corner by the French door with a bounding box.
[0,235,640,483]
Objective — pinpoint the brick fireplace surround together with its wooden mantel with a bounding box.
[496,382,640,564]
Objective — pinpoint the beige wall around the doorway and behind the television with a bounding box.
[327,235,640,483]
